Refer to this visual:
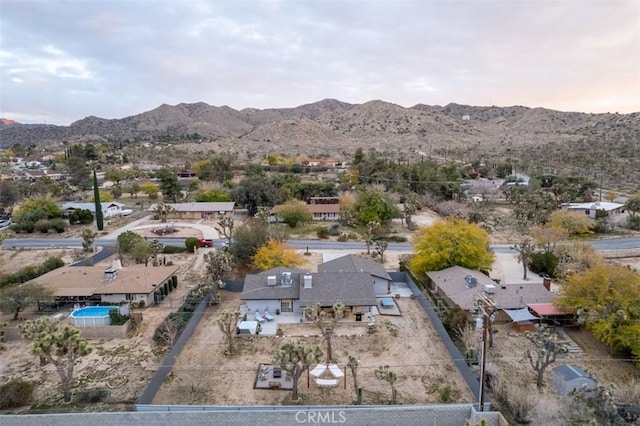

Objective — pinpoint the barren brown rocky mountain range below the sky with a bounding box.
[0,99,640,188]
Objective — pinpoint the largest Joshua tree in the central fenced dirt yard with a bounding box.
[273,340,322,401]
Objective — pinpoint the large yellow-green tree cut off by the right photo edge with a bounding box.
[554,263,640,362]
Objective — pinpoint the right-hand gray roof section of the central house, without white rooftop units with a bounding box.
[300,272,376,306]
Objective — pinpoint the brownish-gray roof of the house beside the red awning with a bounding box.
[427,266,556,311]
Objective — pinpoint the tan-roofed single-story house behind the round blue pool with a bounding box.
[31,262,178,306]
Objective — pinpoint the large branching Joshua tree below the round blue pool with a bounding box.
[18,319,91,402]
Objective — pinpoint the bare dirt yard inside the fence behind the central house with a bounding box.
[154,292,473,405]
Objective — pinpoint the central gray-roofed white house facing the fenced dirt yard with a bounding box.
[240,255,380,321]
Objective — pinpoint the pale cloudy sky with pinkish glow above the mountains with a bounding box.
[0,0,640,125]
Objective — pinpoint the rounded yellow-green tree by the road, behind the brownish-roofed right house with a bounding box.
[411,218,495,274]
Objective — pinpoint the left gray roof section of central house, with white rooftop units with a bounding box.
[240,266,307,300]
